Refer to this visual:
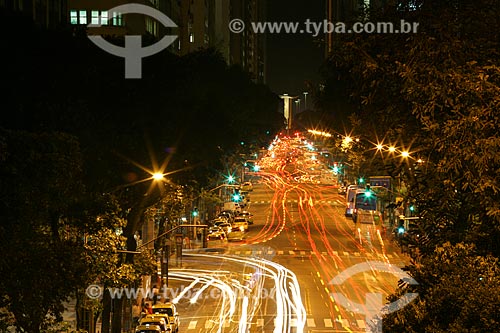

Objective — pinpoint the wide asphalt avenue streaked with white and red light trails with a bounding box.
[170,170,408,333]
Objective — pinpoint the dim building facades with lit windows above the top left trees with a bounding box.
[0,0,266,83]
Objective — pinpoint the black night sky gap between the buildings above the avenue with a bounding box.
[267,0,325,95]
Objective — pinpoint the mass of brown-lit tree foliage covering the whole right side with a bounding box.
[322,0,500,332]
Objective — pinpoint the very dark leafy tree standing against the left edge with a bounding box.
[0,130,83,332]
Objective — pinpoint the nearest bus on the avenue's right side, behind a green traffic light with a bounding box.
[352,189,382,225]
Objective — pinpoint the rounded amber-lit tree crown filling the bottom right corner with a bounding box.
[382,243,500,333]
